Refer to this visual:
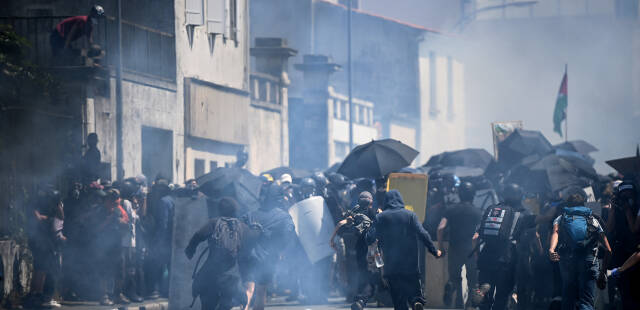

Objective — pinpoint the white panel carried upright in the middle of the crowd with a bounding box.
[289,196,335,264]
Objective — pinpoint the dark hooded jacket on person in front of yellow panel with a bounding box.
[367,190,437,276]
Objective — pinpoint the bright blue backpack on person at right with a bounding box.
[559,207,600,250]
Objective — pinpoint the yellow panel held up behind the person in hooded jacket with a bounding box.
[387,173,429,223]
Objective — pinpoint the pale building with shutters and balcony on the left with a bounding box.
[2,0,296,183]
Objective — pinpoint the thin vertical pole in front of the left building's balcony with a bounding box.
[116,0,124,180]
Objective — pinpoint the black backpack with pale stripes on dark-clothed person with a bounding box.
[478,204,520,242]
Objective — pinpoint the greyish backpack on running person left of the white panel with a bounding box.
[209,217,241,259]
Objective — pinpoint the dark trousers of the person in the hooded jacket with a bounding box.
[385,274,425,310]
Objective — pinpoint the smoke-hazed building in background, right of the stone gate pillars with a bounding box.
[250,0,465,164]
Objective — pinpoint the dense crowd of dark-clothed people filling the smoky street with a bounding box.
[20,136,640,310]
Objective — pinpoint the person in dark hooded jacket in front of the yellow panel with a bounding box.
[367,190,442,310]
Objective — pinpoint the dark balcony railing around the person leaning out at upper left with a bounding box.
[0,16,176,82]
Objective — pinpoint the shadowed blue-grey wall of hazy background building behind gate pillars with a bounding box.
[251,0,424,148]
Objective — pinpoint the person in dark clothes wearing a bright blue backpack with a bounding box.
[549,187,611,310]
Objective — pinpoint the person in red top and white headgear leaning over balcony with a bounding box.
[49,5,104,56]
